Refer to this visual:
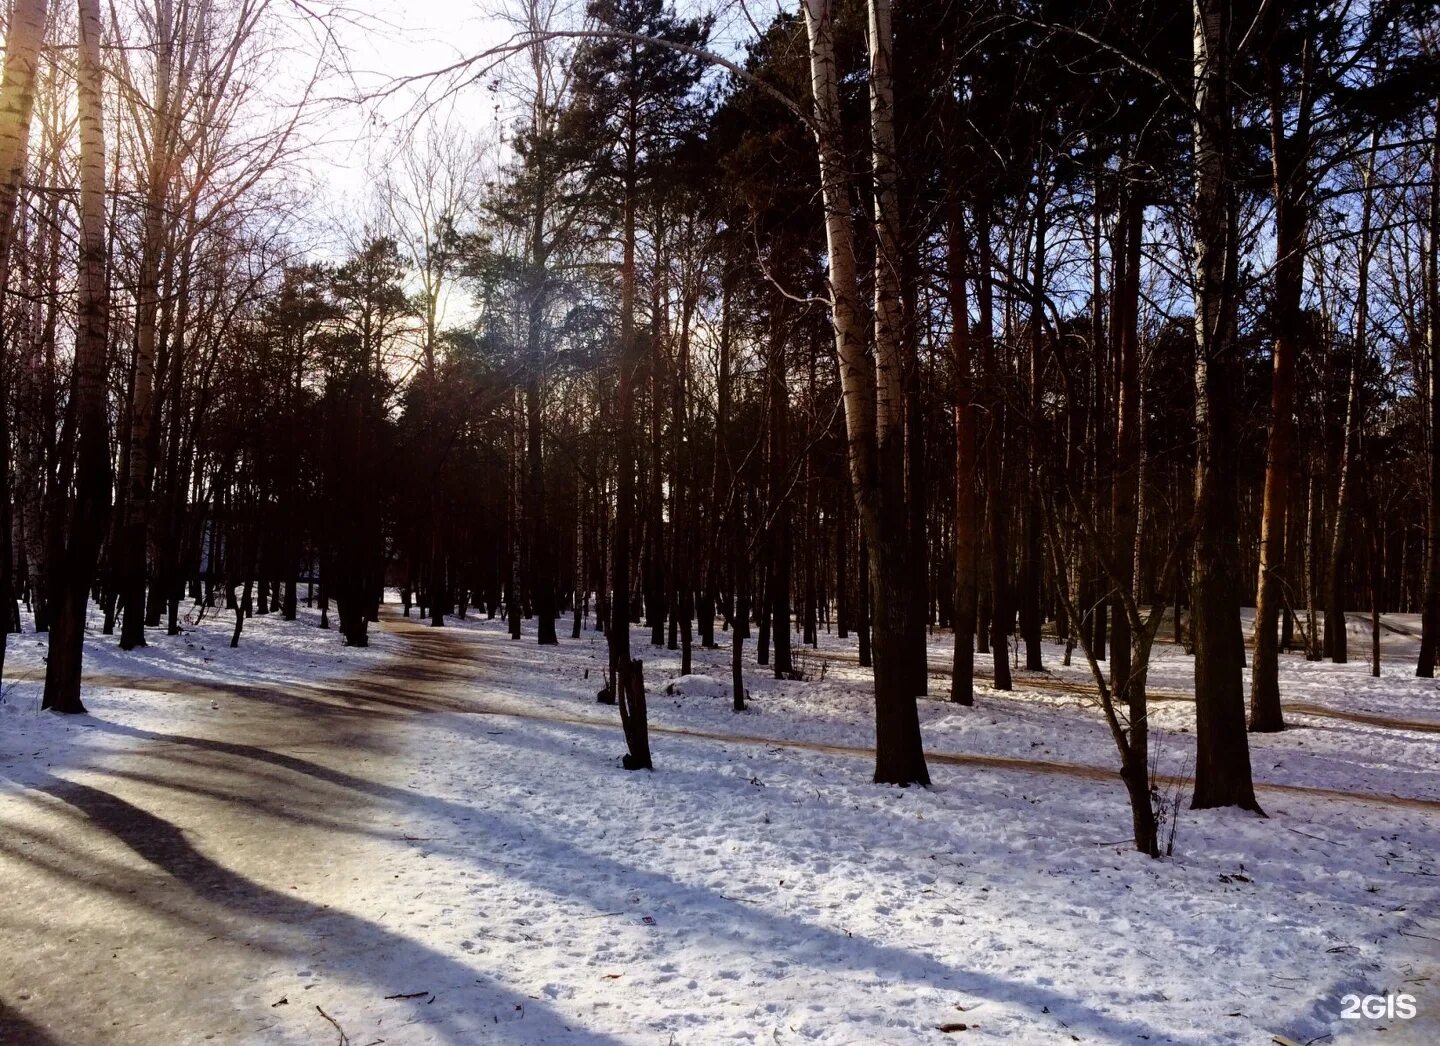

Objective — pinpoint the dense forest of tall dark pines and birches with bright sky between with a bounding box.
[0,0,1440,1042]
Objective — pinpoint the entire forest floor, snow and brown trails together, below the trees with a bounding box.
[0,607,1440,1046]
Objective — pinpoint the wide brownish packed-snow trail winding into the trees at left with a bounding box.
[0,618,607,1046]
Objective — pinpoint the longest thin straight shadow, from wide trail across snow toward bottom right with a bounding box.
[78,720,1175,1042]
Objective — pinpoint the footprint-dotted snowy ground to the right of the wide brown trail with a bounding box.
[256,610,1440,1043]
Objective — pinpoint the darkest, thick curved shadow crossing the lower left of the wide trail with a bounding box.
[21,777,618,1043]
